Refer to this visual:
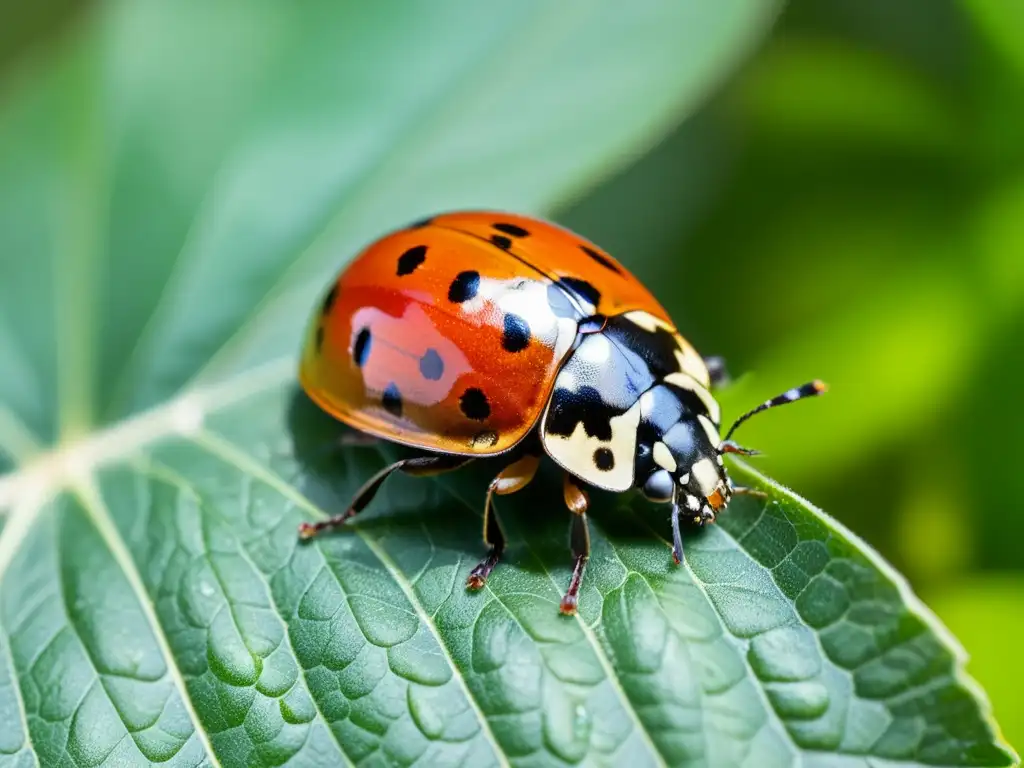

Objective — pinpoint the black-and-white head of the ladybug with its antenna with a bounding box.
[638,381,825,524]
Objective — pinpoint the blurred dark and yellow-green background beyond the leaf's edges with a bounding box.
[0,0,1024,743]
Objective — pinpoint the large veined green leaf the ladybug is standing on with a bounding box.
[0,0,1014,767]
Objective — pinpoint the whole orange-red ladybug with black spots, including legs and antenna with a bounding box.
[299,211,825,613]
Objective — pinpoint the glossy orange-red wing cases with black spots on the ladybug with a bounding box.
[300,212,669,455]
